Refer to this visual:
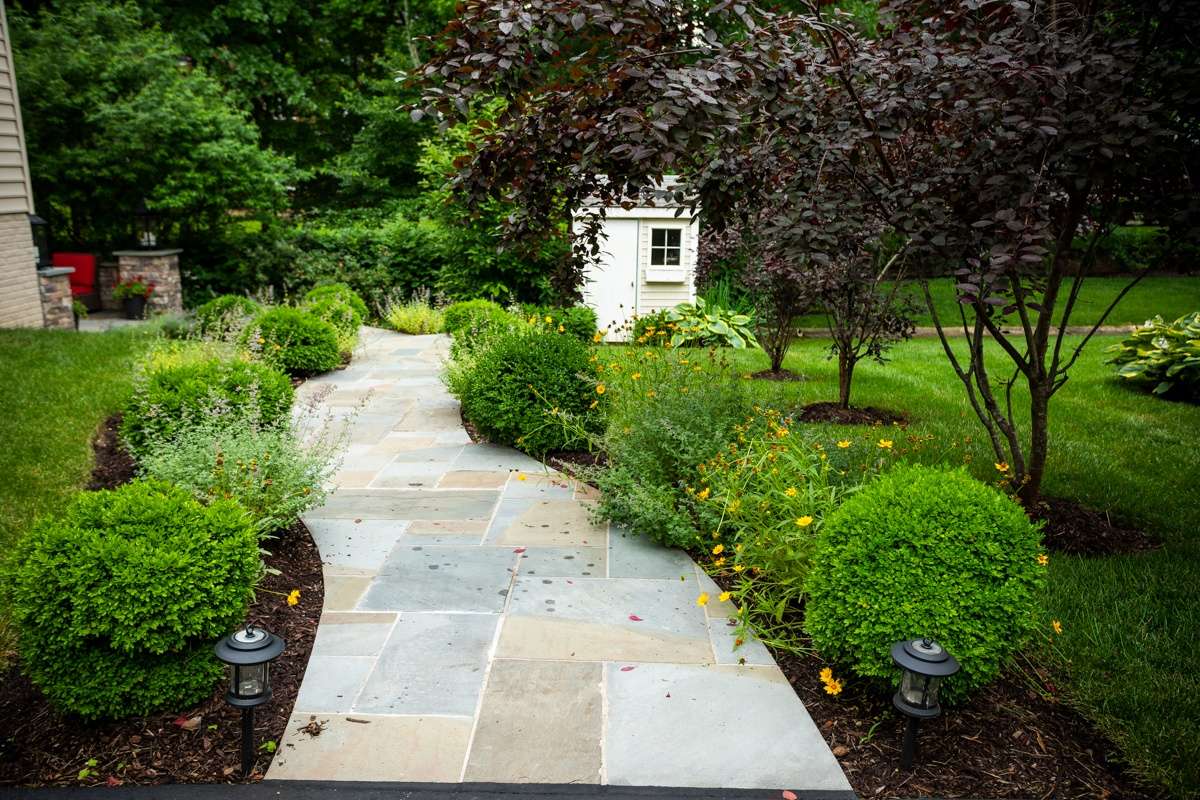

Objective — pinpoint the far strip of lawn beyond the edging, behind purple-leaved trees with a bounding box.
[798,276,1200,327]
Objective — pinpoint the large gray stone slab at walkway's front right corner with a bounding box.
[605,663,850,792]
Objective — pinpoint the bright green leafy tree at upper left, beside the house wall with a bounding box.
[10,2,294,249]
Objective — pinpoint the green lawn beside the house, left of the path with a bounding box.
[0,330,148,662]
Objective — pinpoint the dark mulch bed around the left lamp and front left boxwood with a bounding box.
[0,524,324,786]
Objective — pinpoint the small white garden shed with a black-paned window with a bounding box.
[572,178,700,342]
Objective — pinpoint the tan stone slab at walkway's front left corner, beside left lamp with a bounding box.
[266,714,472,783]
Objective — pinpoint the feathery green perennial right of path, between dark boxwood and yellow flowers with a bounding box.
[594,347,748,547]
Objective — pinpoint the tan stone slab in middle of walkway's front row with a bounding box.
[463,661,604,783]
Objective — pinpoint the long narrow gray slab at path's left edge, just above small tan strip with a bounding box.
[306,489,499,519]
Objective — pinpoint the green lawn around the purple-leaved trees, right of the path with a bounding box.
[600,337,1200,796]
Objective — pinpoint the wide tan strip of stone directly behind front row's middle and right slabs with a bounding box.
[496,615,714,664]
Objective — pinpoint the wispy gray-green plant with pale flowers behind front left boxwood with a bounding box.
[139,415,340,535]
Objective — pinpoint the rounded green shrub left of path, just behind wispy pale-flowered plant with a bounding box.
[121,344,294,455]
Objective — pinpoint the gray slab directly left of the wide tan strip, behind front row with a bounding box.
[354,614,499,716]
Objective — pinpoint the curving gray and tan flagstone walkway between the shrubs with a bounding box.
[268,329,853,796]
